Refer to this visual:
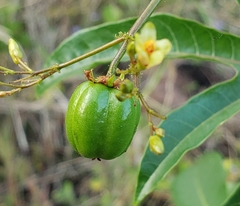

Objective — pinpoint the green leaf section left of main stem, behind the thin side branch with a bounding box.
[37,19,134,96]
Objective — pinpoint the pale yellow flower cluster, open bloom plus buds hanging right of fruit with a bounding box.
[127,22,172,155]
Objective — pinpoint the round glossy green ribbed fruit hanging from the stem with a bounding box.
[66,81,140,159]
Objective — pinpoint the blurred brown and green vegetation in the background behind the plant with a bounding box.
[0,0,240,206]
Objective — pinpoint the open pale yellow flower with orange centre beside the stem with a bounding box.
[135,22,172,70]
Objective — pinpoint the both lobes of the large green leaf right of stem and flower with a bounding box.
[135,15,240,204]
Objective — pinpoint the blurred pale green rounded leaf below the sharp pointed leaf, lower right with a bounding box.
[171,152,228,206]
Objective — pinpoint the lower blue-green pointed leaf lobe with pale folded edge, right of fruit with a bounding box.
[136,72,240,202]
